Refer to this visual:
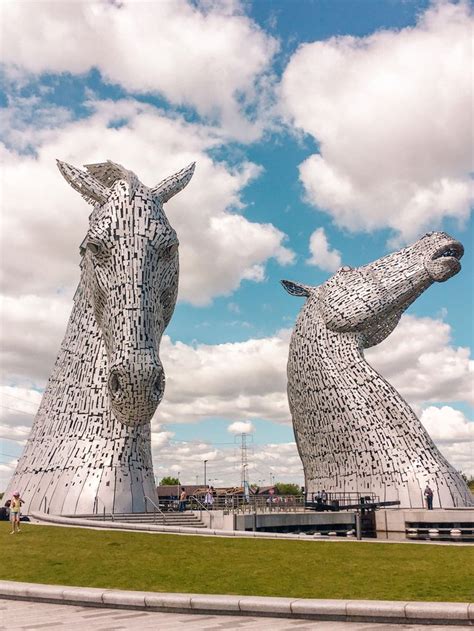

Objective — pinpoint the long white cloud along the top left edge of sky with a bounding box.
[1,0,278,140]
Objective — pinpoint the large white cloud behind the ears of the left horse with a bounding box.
[1,101,294,304]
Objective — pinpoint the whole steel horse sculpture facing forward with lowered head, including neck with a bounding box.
[7,161,194,514]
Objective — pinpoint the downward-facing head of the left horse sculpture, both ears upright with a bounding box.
[58,161,194,425]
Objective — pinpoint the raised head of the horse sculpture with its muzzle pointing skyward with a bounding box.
[282,232,464,348]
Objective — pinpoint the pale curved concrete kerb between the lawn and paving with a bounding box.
[0,581,474,628]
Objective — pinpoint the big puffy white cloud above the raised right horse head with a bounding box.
[281,2,473,239]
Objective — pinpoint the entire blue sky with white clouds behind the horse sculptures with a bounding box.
[0,0,474,490]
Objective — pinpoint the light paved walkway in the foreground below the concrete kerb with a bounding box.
[0,599,472,631]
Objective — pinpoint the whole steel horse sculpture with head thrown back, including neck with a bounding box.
[282,232,472,508]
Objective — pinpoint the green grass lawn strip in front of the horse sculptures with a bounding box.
[0,522,474,601]
